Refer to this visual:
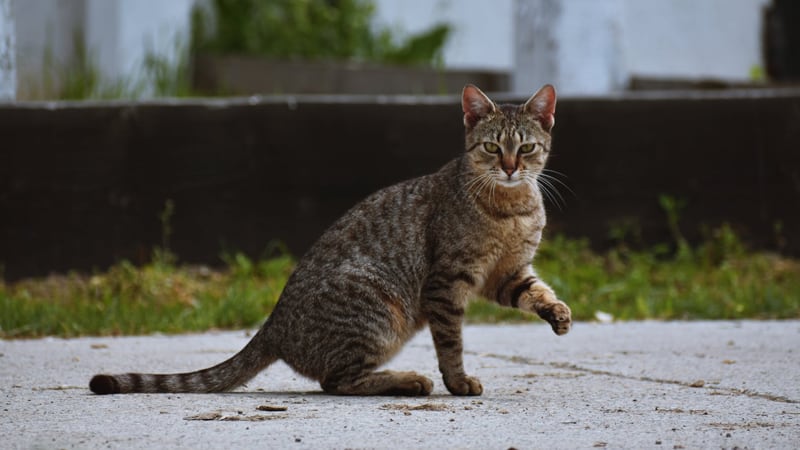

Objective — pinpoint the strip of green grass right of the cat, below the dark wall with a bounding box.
[467,227,800,322]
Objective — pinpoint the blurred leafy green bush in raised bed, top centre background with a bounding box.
[191,0,451,65]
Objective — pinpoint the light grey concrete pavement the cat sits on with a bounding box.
[0,321,800,449]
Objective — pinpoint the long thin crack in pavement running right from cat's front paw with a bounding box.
[464,350,800,404]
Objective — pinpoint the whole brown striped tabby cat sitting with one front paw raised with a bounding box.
[89,85,571,395]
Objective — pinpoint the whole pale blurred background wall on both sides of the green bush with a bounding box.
[14,0,769,95]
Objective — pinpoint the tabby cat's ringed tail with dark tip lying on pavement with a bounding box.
[89,328,278,394]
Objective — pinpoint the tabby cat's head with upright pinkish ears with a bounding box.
[461,84,556,189]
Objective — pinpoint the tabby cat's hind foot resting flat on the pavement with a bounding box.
[321,370,433,396]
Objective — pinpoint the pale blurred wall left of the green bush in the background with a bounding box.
[12,0,195,99]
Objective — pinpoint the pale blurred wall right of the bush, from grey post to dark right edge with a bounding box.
[513,0,768,95]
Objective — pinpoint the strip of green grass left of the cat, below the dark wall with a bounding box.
[0,254,294,338]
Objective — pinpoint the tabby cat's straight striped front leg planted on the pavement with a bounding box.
[422,283,483,395]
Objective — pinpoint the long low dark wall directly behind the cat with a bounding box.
[0,90,800,278]
